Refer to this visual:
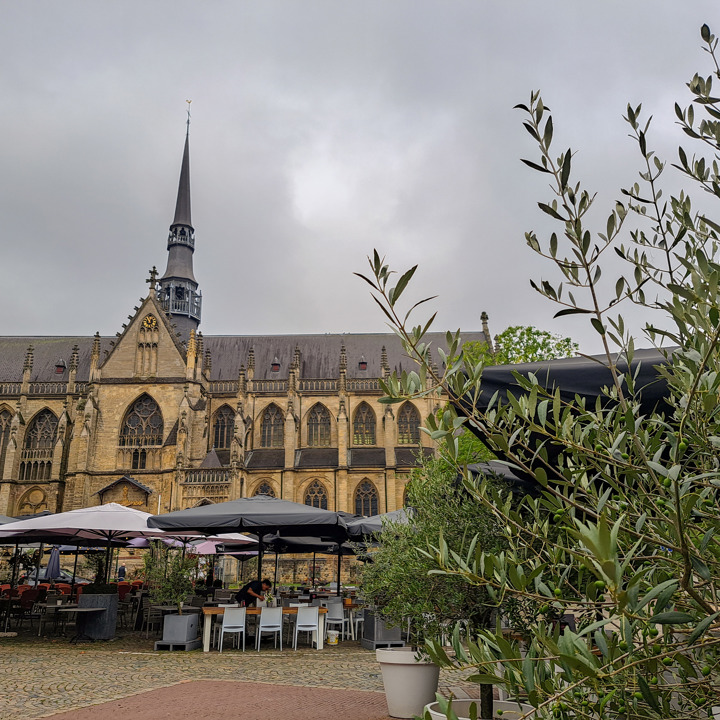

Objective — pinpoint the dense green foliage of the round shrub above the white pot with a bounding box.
[360,459,500,641]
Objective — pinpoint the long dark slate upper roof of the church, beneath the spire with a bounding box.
[0,332,485,382]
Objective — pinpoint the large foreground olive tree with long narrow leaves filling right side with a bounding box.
[365,26,720,720]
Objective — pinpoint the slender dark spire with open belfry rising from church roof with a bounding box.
[158,100,202,339]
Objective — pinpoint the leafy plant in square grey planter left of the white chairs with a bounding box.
[145,549,198,645]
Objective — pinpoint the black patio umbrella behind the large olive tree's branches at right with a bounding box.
[453,349,670,485]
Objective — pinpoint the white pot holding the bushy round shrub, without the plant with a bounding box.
[375,647,440,718]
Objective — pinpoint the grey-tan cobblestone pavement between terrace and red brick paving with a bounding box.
[0,632,478,720]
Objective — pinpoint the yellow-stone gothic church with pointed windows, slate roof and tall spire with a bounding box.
[0,129,489,515]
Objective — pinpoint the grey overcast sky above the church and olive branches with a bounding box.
[0,0,720,350]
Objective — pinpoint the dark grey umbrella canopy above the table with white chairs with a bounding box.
[148,495,347,540]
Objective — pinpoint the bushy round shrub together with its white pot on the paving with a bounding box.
[361,459,501,718]
